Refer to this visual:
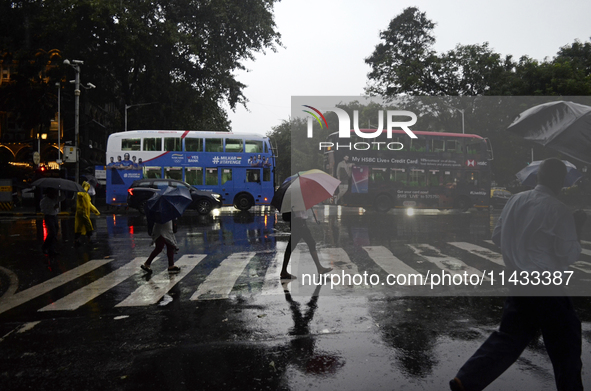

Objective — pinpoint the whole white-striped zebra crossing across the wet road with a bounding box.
[0,241,591,314]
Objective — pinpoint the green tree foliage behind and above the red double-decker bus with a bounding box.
[365,7,591,188]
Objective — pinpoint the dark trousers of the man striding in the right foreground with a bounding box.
[457,297,583,391]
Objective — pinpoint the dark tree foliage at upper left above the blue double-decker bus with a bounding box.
[0,0,281,130]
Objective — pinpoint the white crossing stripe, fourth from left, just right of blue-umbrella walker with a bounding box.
[191,252,256,300]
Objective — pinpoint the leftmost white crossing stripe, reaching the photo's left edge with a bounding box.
[0,259,113,314]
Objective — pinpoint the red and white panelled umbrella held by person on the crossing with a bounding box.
[271,169,341,213]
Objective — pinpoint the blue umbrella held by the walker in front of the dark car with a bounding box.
[144,186,193,224]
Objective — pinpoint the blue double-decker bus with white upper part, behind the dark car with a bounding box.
[106,130,275,210]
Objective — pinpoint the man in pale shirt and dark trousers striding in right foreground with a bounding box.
[450,158,586,391]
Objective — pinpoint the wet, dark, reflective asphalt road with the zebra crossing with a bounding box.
[0,207,591,390]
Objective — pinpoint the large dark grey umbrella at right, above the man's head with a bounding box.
[507,101,591,164]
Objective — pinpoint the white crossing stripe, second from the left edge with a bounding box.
[39,257,146,311]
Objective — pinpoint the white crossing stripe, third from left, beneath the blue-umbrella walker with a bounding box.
[115,254,207,307]
